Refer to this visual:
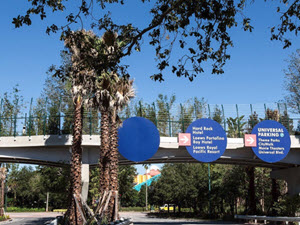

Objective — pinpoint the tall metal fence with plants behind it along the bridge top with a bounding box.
[0,98,300,137]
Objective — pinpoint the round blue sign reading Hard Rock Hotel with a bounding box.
[186,119,227,162]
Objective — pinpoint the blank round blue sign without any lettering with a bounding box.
[119,117,160,162]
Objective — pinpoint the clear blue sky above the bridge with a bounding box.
[0,0,300,174]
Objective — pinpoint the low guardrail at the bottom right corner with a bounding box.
[234,215,300,225]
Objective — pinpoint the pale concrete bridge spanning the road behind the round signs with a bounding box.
[0,135,300,198]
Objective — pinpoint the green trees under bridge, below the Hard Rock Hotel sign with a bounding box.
[149,164,208,213]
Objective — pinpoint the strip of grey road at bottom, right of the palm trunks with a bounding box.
[120,212,241,225]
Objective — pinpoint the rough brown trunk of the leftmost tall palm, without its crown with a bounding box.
[66,97,83,225]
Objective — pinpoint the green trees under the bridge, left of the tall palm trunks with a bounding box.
[7,164,70,208]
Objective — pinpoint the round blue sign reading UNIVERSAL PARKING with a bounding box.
[252,120,291,163]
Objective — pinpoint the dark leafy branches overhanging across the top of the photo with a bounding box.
[13,0,300,81]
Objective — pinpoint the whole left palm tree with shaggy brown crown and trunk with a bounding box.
[62,30,97,225]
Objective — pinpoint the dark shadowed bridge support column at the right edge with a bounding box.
[271,167,300,195]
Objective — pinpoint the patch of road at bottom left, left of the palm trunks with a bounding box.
[0,212,62,225]
